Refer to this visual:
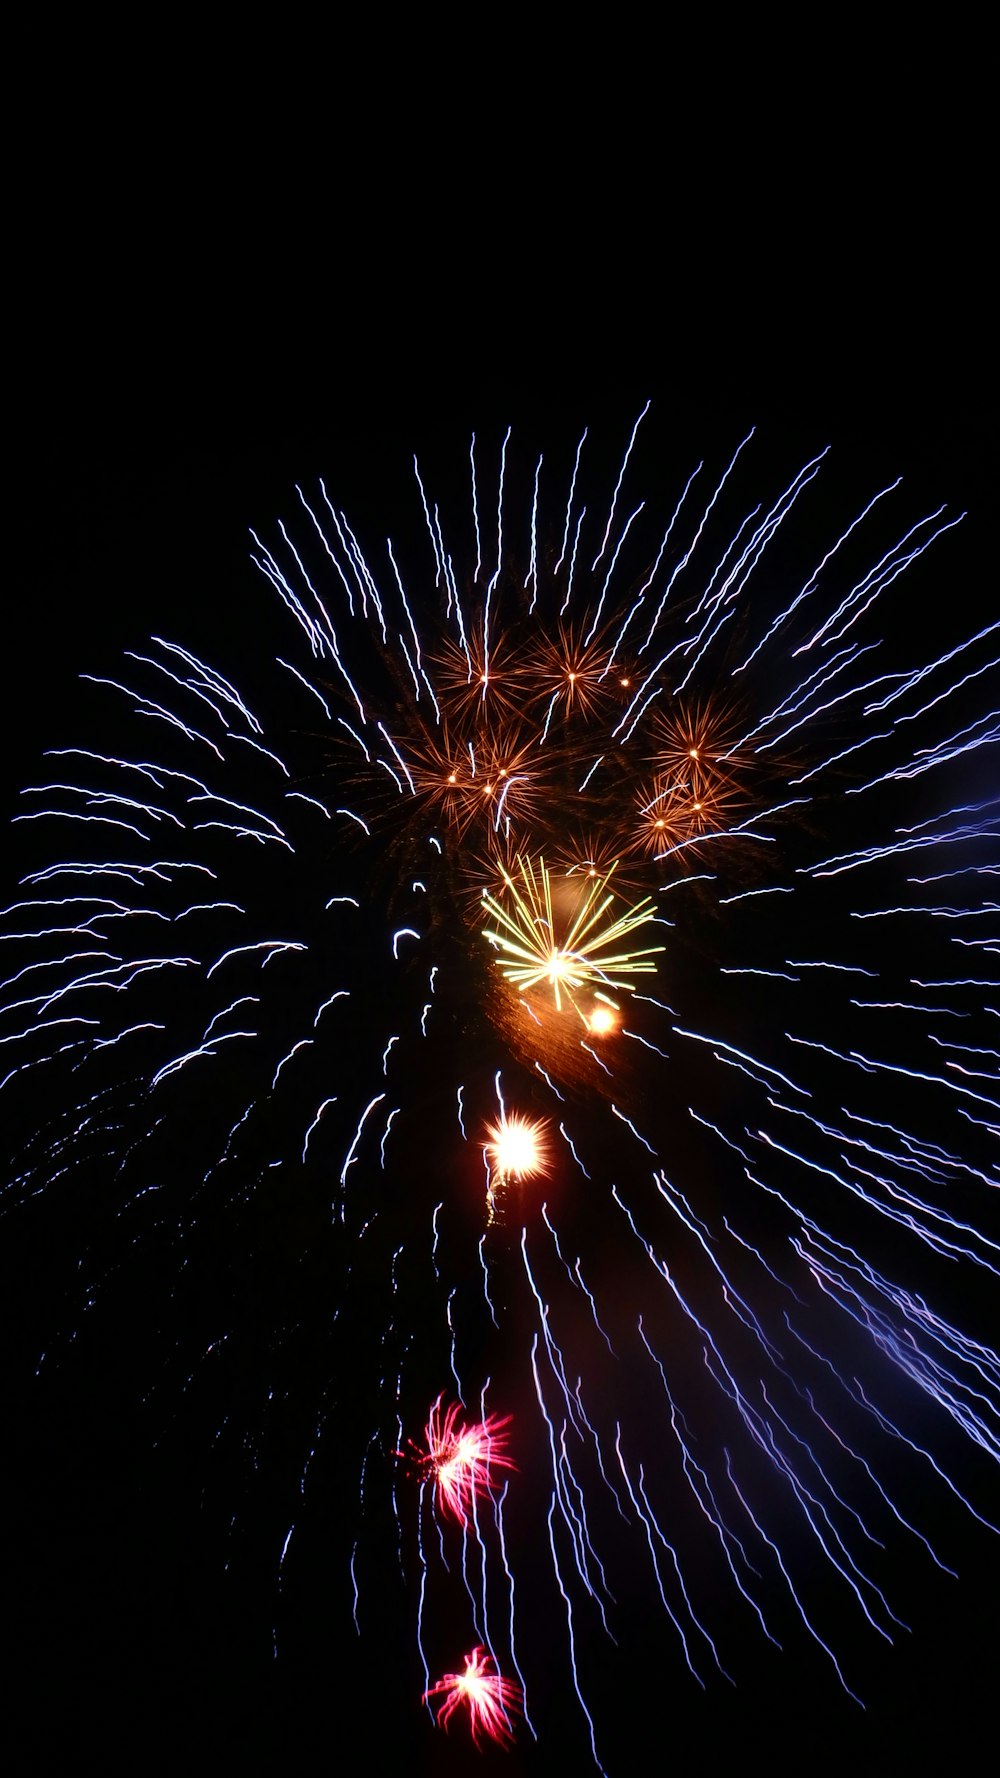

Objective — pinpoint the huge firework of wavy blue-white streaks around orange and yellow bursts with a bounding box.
[0,421,1000,1766]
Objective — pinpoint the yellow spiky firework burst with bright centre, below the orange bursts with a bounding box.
[482,857,664,1019]
